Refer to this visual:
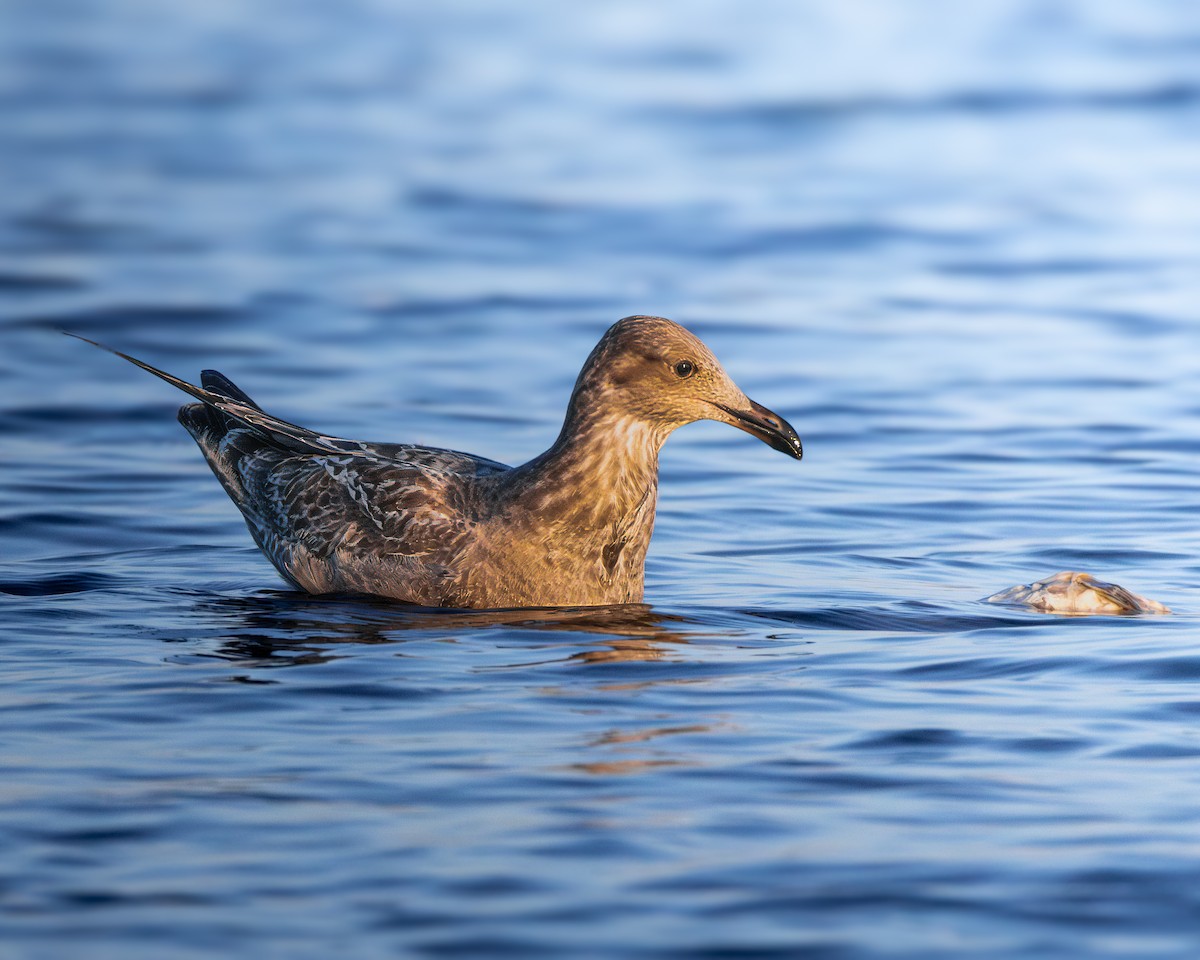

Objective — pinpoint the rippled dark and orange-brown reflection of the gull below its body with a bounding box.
[180,590,730,778]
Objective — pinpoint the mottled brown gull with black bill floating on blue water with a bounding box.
[70,317,803,608]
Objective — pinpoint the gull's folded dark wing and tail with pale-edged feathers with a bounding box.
[68,334,509,600]
